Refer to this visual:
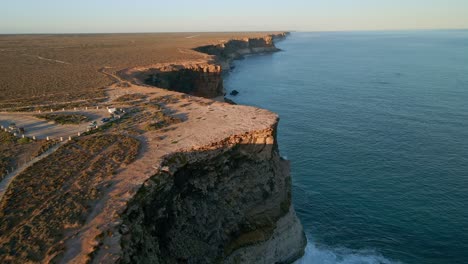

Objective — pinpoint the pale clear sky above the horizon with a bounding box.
[0,0,468,33]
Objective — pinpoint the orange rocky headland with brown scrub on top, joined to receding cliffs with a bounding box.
[0,33,306,263]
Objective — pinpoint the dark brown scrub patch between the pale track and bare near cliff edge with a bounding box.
[0,134,139,263]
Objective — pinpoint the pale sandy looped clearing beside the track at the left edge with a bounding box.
[0,109,109,139]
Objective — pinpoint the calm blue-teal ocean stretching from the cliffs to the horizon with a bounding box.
[225,30,468,264]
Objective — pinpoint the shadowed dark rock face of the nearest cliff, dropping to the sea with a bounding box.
[121,125,305,263]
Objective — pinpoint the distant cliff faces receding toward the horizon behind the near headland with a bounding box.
[118,33,287,98]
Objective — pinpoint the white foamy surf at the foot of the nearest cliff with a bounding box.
[294,241,401,264]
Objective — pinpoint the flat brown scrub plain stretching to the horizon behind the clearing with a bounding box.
[0,32,282,106]
